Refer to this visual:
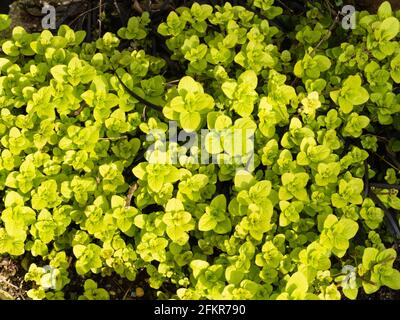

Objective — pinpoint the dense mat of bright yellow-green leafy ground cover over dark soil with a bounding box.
[0,0,400,300]
